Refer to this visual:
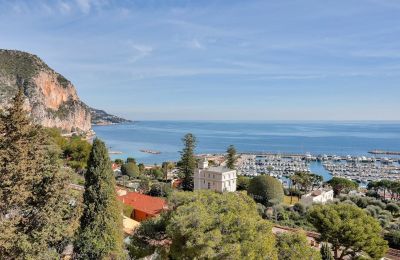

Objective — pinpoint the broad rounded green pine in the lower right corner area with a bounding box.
[309,203,387,259]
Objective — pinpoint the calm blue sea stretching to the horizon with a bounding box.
[93,121,400,179]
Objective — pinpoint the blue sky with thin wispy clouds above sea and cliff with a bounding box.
[0,0,400,120]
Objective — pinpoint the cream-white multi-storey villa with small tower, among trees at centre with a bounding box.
[193,159,236,192]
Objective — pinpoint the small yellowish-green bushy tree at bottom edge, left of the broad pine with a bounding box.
[276,232,321,260]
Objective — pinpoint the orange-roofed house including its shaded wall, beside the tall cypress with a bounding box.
[118,192,167,222]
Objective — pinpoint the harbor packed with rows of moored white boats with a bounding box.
[238,152,400,186]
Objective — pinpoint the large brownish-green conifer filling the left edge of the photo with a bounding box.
[0,88,79,259]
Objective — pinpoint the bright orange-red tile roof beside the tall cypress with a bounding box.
[118,192,167,215]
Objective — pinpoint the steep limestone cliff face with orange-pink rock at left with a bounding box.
[0,50,91,132]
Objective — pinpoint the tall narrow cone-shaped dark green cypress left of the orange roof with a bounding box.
[75,139,123,259]
